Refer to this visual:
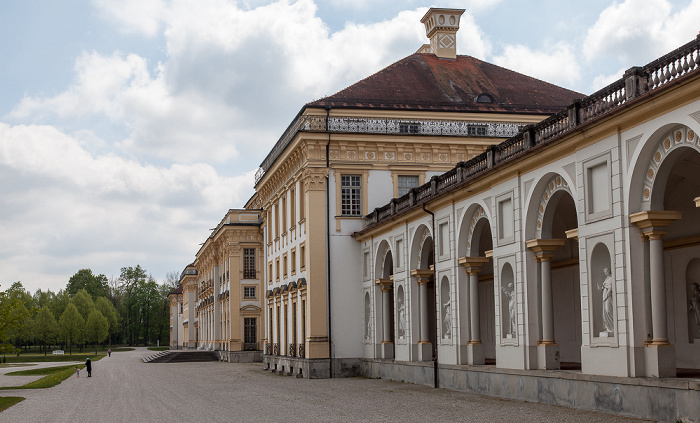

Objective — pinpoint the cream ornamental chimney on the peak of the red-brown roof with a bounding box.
[419,7,464,59]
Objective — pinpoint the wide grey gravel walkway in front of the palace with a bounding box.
[0,348,634,423]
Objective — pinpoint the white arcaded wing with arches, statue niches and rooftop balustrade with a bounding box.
[353,37,700,420]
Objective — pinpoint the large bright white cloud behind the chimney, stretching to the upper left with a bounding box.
[13,0,489,163]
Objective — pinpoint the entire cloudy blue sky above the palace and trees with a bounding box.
[0,0,700,292]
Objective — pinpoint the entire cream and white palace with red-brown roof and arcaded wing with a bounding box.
[171,9,700,420]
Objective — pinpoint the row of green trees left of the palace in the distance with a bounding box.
[0,265,179,354]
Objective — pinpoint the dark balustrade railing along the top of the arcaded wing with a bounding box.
[363,35,700,228]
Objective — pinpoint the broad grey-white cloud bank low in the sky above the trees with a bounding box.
[0,123,254,290]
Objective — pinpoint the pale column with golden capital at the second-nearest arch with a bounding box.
[525,239,566,370]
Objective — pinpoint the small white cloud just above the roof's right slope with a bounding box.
[492,42,581,87]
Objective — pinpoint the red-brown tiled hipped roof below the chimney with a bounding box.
[307,53,584,114]
